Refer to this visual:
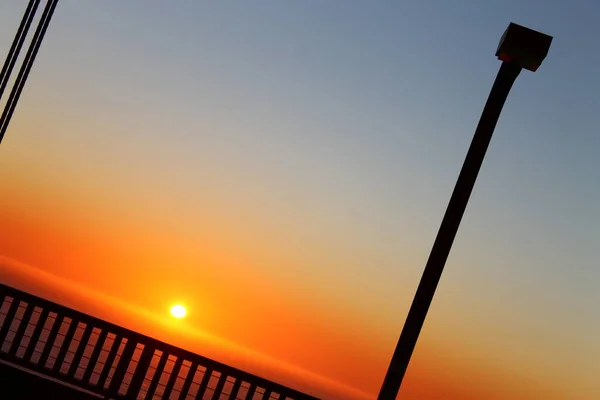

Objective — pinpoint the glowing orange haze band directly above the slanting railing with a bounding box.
[0,256,369,400]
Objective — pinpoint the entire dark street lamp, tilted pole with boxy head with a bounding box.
[377,23,552,400]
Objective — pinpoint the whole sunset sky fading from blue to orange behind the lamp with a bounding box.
[0,0,600,400]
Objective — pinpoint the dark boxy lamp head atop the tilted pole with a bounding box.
[496,22,552,71]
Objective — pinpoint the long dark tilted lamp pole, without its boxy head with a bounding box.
[378,62,521,400]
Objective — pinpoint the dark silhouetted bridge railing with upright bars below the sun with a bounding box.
[0,284,316,400]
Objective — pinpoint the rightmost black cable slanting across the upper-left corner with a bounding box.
[0,0,58,143]
